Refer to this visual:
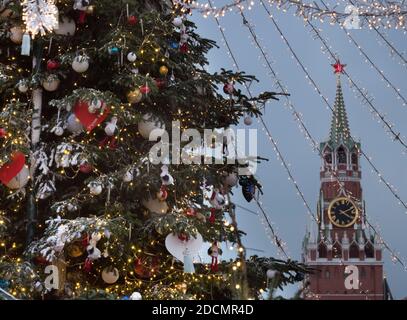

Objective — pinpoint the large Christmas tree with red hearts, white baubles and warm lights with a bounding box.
[0,0,306,299]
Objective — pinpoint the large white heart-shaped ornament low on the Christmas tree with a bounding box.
[165,233,203,261]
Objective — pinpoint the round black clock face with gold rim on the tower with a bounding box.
[328,198,359,228]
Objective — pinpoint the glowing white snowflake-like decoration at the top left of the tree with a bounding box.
[22,0,58,38]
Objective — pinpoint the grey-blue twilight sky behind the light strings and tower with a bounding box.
[192,0,407,298]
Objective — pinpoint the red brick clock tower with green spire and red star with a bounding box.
[303,60,385,300]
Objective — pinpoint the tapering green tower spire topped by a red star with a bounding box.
[329,59,352,147]
